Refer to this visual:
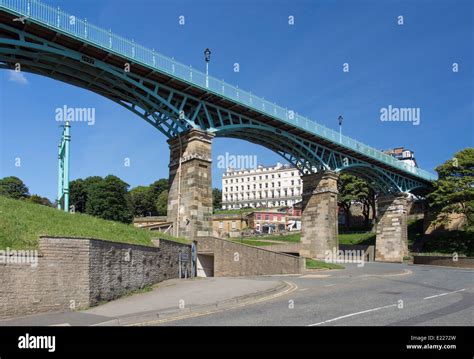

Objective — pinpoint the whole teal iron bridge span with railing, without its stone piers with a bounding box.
[0,0,435,194]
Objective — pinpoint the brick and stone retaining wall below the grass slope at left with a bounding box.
[0,237,191,318]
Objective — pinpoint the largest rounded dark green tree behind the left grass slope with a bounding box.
[86,175,133,223]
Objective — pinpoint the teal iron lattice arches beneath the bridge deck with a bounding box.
[0,20,426,193]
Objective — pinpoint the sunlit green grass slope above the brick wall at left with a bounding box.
[0,196,188,249]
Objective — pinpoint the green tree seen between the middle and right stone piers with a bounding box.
[337,173,369,230]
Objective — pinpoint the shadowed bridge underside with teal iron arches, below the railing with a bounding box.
[0,11,429,194]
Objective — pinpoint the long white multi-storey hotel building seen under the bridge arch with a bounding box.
[222,163,303,209]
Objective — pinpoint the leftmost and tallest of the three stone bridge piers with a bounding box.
[167,129,214,239]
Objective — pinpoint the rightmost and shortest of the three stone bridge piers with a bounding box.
[375,193,408,262]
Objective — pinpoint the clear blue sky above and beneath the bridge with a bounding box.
[0,0,474,200]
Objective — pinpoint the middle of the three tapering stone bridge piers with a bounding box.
[300,171,339,259]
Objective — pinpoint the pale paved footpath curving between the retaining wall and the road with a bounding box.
[0,278,292,326]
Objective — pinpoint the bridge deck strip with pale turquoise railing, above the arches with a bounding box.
[0,0,435,186]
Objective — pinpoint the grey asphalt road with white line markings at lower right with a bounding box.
[154,263,474,326]
